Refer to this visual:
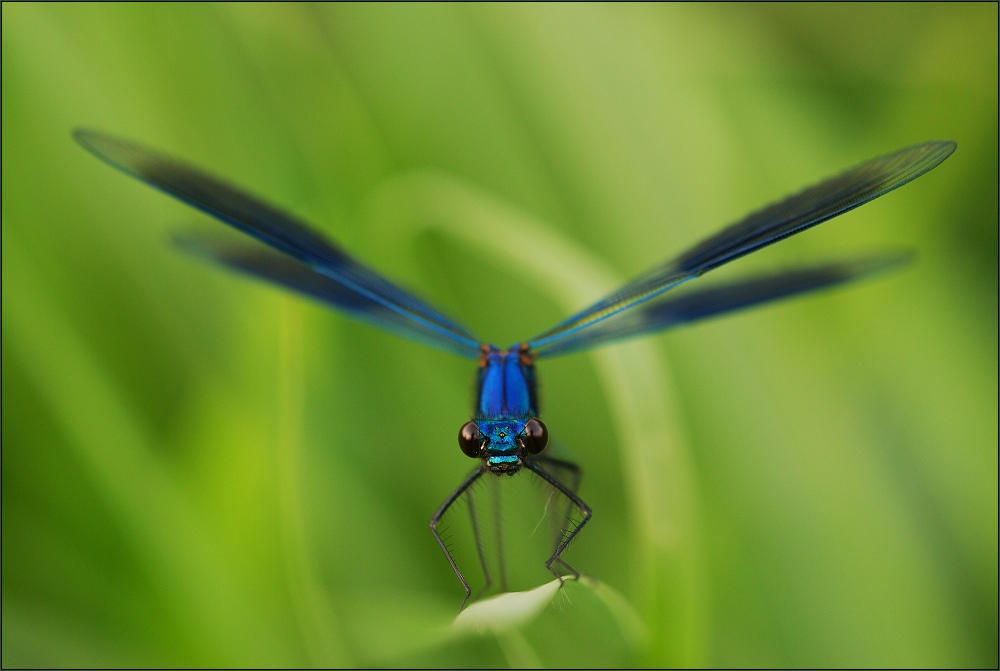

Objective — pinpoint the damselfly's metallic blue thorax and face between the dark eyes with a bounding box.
[473,345,538,475]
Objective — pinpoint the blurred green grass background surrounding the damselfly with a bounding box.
[2,3,998,667]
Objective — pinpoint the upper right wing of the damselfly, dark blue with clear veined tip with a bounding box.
[528,142,956,353]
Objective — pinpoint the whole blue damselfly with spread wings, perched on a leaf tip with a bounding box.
[75,130,955,606]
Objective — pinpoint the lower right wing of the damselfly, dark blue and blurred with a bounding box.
[536,254,909,357]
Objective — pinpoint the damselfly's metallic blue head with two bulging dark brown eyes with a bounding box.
[458,417,549,475]
